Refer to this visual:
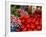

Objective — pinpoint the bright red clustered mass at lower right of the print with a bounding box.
[20,14,42,31]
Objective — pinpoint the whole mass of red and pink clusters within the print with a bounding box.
[11,6,42,32]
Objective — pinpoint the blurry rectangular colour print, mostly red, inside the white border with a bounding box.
[10,5,42,32]
